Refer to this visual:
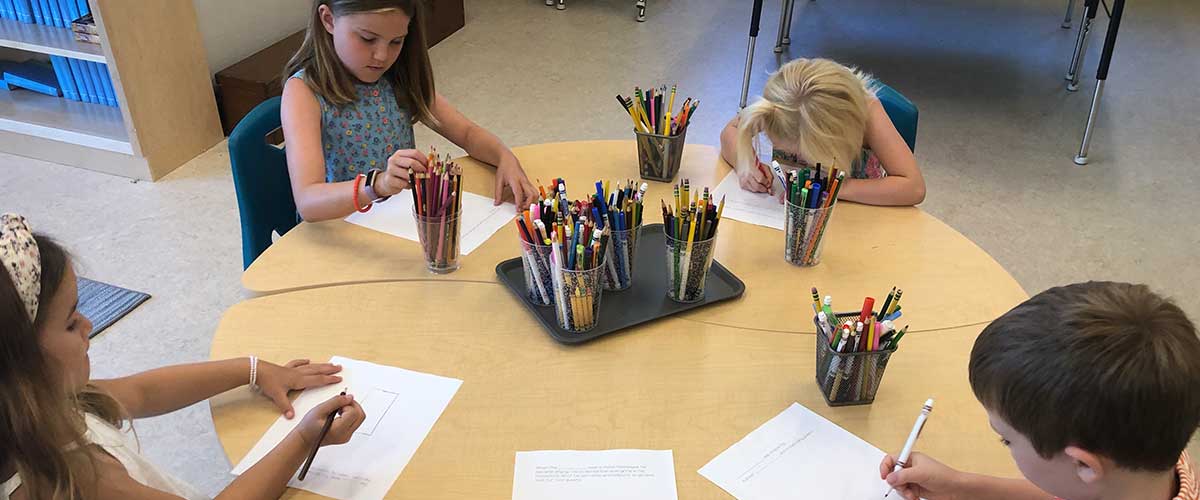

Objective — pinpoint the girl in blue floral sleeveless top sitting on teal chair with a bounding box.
[280,0,536,221]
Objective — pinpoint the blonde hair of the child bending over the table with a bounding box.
[737,59,875,171]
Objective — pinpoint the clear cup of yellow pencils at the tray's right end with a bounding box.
[662,180,725,303]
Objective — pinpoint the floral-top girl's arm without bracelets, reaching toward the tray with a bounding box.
[426,94,538,207]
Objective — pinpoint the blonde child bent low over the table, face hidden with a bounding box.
[721,59,925,205]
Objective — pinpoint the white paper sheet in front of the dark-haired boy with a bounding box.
[700,403,889,500]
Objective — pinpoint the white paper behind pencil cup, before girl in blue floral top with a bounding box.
[346,192,517,255]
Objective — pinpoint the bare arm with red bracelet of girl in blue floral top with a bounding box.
[280,78,427,222]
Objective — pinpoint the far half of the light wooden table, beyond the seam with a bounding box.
[242,140,1027,333]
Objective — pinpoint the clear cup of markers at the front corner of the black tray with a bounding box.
[550,233,605,333]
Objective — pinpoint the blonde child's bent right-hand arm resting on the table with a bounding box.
[838,100,925,206]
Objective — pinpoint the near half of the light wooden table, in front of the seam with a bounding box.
[212,279,1018,499]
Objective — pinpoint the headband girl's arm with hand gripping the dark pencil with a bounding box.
[73,396,366,500]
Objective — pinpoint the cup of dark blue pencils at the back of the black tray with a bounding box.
[595,181,649,291]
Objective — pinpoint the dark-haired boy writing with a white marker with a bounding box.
[880,282,1200,500]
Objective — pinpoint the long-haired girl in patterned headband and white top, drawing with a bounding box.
[0,213,364,500]
